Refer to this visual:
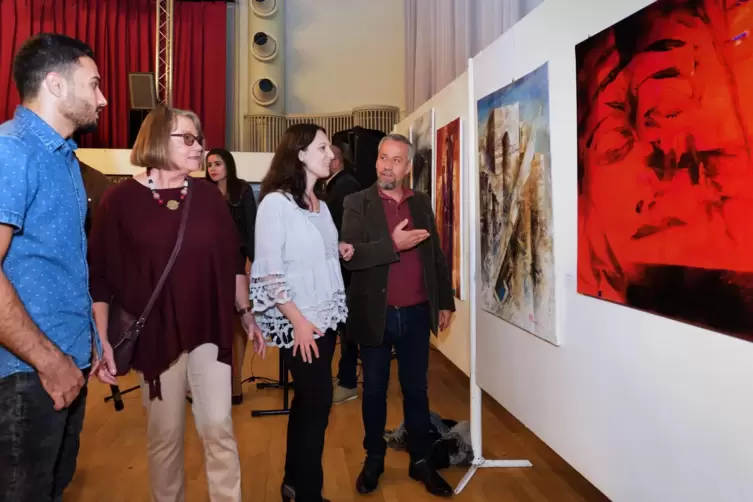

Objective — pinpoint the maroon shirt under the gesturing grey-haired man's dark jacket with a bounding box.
[379,188,429,308]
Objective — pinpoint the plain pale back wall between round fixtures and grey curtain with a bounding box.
[284,0,405,114]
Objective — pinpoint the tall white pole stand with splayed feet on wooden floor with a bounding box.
[455,58,533,494]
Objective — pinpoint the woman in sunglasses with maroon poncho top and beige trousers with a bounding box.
[90,106,265,502]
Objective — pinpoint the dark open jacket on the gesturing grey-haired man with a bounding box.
[340,185,455,346]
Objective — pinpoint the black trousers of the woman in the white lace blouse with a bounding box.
[282,330,337,502]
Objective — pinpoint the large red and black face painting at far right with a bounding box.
[576,0,753,341]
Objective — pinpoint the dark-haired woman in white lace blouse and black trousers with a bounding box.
[251,124,353,502]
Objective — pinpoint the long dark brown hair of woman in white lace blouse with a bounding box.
[259,124,327,209]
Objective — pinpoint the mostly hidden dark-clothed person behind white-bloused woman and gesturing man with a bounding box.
[325,145,361,404]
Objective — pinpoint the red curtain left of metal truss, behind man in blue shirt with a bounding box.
[0,0,154,148]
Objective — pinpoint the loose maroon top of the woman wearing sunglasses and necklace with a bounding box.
[89,179,245,399]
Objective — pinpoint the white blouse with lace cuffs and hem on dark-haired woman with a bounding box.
[251,192,348,348]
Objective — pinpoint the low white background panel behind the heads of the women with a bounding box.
[76,148,274,183]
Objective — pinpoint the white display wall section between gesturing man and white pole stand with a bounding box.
[395,72,470,375]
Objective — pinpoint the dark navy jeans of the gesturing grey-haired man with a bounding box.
[360,304,431,462]
